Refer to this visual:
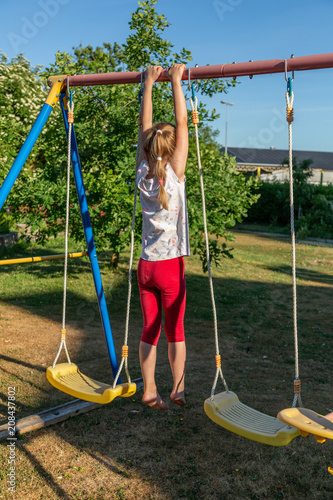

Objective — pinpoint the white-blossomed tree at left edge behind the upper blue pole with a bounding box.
[0,52,60,235]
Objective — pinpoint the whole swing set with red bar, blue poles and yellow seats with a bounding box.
[0,53,333,446]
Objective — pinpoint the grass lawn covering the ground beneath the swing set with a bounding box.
[0,234,333,500]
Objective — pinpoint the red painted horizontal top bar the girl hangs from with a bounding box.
[62,52,333,87]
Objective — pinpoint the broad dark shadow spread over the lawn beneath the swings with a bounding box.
[0,266,333,500]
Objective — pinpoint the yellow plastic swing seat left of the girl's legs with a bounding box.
[46,363,136,404]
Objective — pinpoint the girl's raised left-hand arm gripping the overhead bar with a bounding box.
[139,66,163,165]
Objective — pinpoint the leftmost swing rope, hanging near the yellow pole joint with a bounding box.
[52,85,74,368]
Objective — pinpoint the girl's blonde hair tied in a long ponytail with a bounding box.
[143,123,176,210]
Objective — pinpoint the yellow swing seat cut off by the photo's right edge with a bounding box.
[278,408,333,443]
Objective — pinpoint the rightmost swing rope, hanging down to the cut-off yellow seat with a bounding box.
[286,77,303,408]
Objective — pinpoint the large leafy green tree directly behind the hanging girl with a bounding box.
[0,0,256,270]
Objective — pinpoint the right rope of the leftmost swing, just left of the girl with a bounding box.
[113,80,143,388]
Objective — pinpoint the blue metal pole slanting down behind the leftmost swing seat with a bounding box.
[60,94,121,383]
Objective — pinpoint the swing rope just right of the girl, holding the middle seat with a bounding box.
[190,88,229,399]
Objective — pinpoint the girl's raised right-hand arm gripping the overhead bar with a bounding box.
[168,64,188,181]
